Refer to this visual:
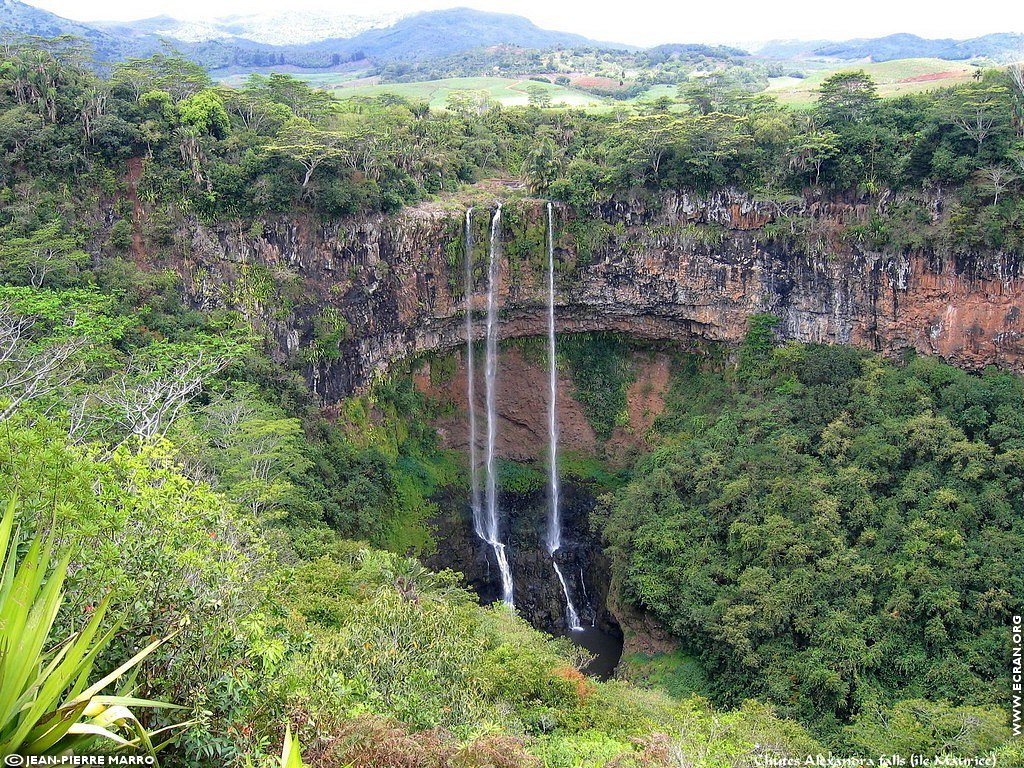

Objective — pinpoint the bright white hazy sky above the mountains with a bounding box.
[29,0,1024,45]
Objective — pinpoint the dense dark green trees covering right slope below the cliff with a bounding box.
[602,327,1024,752]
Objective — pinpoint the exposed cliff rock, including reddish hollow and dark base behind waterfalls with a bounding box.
[153,190,1024,663]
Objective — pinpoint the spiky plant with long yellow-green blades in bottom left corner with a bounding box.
[0,499,186,756]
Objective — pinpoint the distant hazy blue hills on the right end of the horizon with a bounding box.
[757,33,1024,61]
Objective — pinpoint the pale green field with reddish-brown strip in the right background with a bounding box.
[766,58,978,106]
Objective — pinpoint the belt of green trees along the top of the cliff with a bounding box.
[0,40,1024,252]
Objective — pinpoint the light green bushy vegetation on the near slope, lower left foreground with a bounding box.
[0,411,818,768]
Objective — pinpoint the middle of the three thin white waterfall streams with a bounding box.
[483,203,515,607]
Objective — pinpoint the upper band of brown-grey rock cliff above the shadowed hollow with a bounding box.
[176,190,1024,401]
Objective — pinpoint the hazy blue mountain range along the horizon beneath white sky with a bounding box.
[0,0,1024,70]
